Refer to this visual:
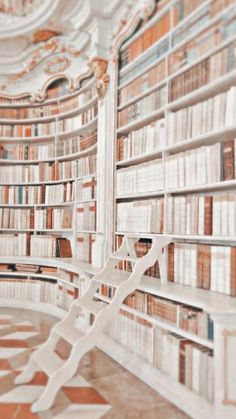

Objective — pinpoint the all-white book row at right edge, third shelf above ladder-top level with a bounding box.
[167,86,236,145]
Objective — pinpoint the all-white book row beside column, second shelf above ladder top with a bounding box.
[116,160,163,197]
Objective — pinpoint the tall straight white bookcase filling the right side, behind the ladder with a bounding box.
[111,0,236,419]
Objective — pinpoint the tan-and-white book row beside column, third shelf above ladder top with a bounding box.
[117,119,165,160]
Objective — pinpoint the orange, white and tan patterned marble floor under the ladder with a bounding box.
[0,308,188,419]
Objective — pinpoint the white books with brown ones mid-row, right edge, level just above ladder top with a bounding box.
[166,192,236,237]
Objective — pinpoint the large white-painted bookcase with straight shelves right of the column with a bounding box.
[106,0,236,419]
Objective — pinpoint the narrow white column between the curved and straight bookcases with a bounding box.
[92,63,117,266]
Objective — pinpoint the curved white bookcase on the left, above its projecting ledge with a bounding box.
[0,77,98,263]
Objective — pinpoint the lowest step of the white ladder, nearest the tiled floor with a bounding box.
[35,349,65,377]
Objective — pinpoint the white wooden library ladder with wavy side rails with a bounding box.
[15,235,171,412]
